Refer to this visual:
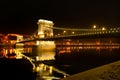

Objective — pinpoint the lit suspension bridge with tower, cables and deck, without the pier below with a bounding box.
[18,19,120,43]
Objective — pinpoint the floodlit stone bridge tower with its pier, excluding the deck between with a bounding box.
[36,19,56,53]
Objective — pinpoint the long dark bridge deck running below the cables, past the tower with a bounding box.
[17,33,120,43]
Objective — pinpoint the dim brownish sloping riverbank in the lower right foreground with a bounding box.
[60,61,120,80]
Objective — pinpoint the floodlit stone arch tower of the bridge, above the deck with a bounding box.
[37,19,54,38]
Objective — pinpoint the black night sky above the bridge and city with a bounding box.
[0,0,120,34]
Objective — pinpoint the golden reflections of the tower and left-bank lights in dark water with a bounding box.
[0,48,60,80]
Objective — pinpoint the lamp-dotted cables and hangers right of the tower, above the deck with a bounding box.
[55,25,120,36]
